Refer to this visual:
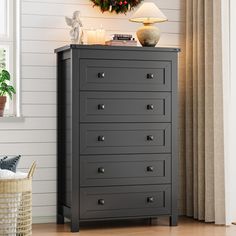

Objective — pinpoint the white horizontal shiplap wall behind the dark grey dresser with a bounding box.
[0,0,185,222]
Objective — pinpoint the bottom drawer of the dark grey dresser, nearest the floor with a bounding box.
[80,185,171,219]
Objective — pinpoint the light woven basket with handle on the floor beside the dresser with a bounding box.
[0,163,36,236]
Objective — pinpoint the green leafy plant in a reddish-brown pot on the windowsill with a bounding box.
[0,70,16,116]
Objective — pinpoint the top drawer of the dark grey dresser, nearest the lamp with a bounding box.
[80,59,171,91]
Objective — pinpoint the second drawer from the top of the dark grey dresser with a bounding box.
[80,92,171,122]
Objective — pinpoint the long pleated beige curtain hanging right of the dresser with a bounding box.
[180,0,225,224]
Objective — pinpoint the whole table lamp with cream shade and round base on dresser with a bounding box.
[130,2,168,47]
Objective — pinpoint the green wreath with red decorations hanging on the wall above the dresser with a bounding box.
[90,0,143,14]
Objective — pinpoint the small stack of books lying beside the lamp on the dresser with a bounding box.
[106,34,137,46]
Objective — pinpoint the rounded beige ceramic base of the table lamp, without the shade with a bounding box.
[137,23,161,47]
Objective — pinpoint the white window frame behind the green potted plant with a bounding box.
[0,0,21,116]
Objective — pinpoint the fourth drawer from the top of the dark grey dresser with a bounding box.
[80,154,171,187]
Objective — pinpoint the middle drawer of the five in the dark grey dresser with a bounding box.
[80,123,171,154]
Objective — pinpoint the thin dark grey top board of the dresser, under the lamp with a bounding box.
[55,44,180,53]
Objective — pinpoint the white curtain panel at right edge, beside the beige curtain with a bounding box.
[221,0,236,225]
